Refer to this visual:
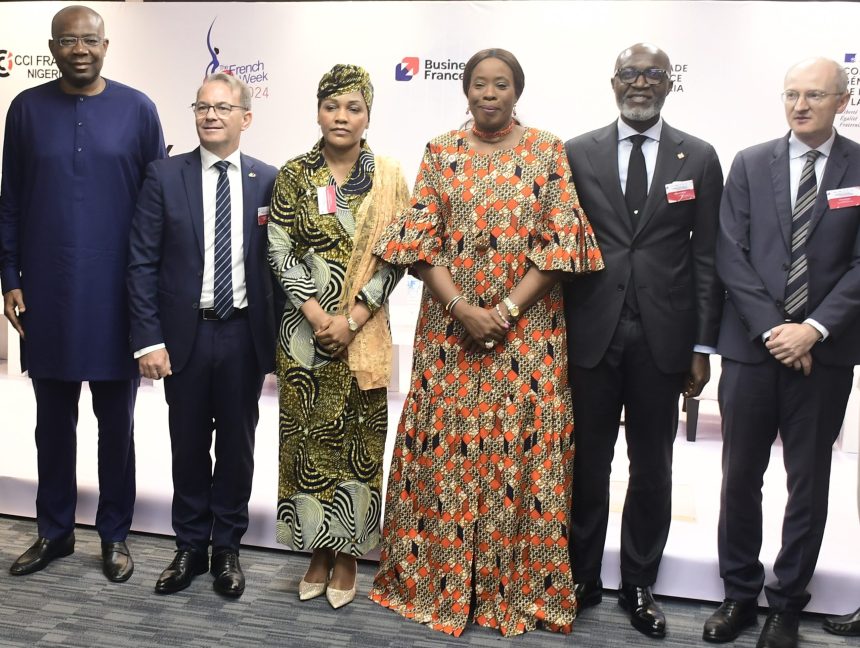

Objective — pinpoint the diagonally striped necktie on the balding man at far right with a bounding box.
[785,149,821,320]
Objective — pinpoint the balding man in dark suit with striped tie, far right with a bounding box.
[704,59,860,648]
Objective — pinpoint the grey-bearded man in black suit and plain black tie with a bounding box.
[564,43,723,638]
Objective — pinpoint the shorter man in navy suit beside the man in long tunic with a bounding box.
[128,74,277,597]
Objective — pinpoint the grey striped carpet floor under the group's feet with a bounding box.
[0,516,848,648]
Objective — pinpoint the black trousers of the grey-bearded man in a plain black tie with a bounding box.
[570,308,684,586]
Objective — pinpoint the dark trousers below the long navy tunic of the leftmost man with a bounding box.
[33,378,140,542]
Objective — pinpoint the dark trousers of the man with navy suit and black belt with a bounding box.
[164,319,265,553]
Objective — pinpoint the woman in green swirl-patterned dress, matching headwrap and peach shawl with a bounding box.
[269,65,409,608]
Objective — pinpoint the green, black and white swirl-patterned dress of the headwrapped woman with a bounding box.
[269,143,403,556]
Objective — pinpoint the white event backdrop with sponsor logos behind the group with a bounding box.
[0,1,860,346]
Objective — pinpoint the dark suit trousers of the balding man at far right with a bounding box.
[719,359,853,612]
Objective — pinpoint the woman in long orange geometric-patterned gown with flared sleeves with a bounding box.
[371,49,603,636]
